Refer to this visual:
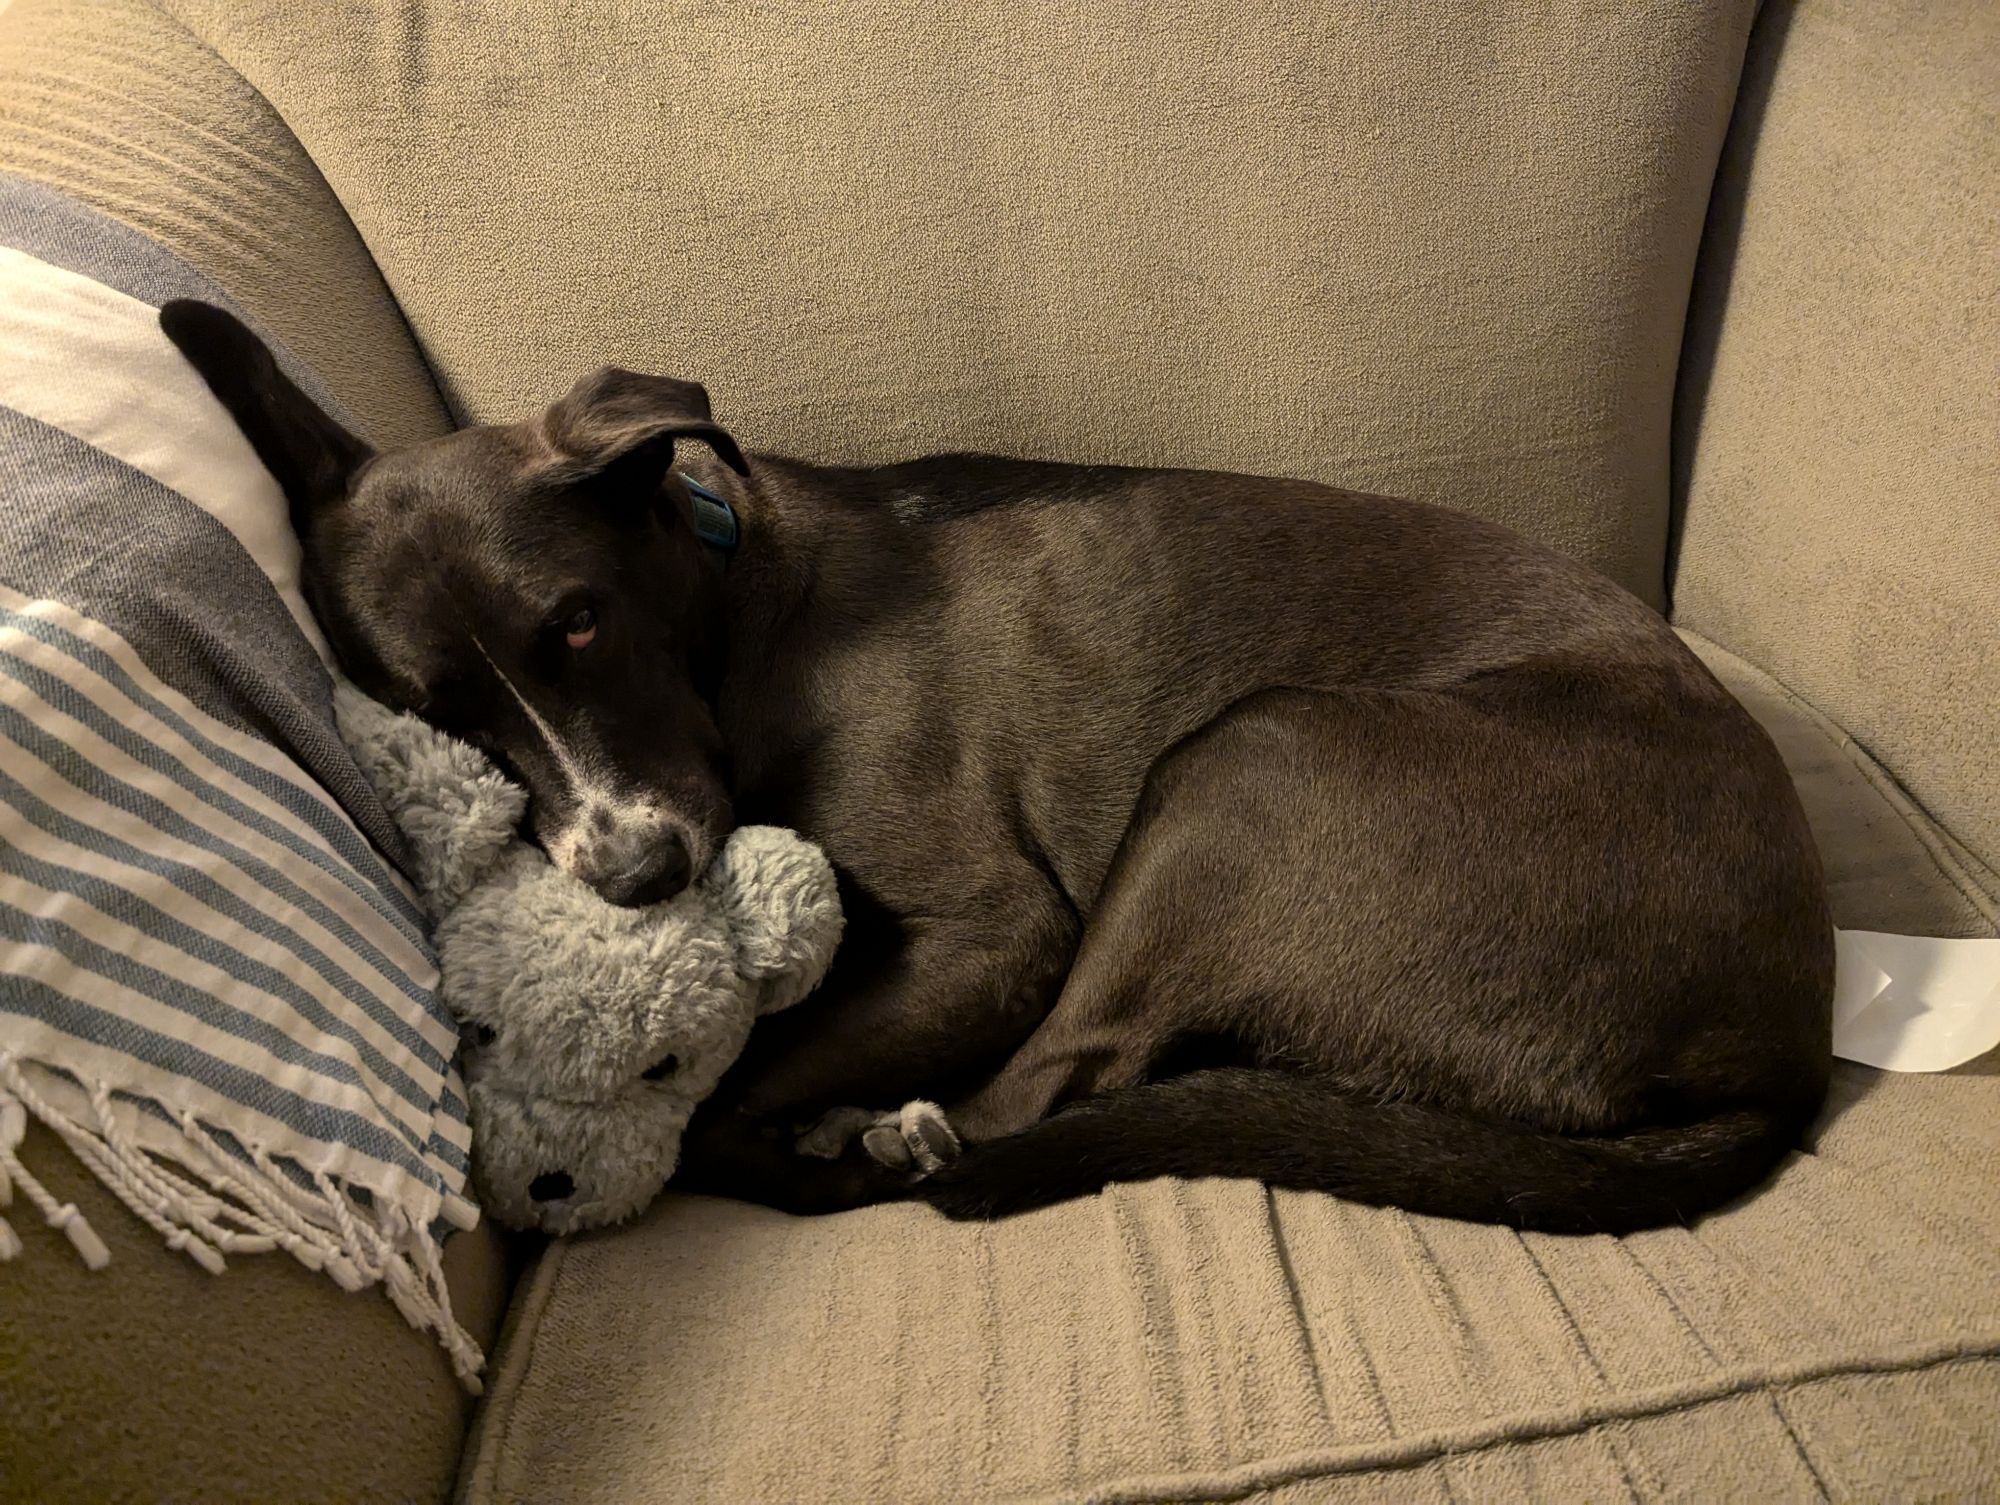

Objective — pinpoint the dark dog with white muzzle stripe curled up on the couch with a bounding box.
[162,302,1832,1231]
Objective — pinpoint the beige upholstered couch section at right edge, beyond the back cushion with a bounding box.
[1670,0,2000,888]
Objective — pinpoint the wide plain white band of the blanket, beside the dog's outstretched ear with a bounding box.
[0,246,332,664]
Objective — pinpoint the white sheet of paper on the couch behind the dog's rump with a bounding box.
[1834,931,2000,1071]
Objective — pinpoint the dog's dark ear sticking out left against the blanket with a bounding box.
[160,298,374,538]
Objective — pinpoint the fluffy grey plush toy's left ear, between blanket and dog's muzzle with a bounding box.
[334,682,528,919]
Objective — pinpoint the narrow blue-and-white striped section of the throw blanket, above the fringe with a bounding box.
[0,588,470,1213]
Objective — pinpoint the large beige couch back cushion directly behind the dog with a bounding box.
[166,0,1752,602]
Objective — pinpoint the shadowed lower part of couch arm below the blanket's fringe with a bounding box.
[0,1125,512,1505]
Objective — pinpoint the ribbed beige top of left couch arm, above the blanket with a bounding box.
[0,0,448,444]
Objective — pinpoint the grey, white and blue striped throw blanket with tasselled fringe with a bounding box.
[0,176,482,1387]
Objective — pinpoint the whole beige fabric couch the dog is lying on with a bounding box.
[0,0,2000,1501]
